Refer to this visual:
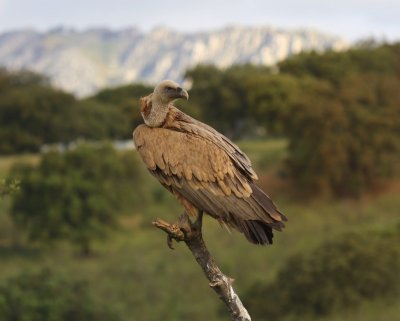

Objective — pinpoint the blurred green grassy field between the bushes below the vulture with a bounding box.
[0,140,400,321]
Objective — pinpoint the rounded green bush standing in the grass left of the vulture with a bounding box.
[12,145,145,254]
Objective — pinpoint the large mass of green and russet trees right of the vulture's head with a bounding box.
[186,44,400,196]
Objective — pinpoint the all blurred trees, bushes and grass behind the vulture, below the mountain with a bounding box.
[0,43,400,321]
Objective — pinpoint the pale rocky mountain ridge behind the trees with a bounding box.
[0,27,347,96]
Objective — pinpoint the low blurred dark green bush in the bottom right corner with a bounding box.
[246,234,400,320]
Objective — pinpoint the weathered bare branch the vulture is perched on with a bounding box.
[153,213,251,321]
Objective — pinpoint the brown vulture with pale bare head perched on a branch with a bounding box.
[133,80,287,245]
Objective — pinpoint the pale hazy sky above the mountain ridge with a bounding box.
[0,0,400,40]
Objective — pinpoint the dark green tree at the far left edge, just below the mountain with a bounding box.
[0,80,75,154]
